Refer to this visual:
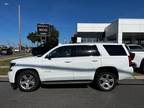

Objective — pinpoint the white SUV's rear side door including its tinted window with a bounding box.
[72,45,101,80]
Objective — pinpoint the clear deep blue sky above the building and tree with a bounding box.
[0,0,144,45]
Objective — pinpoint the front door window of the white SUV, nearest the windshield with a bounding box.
[49,46,72,58]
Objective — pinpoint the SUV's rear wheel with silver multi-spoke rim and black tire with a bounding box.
[94,70,118,91]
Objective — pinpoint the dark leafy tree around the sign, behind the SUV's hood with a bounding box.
[27,26,59,55]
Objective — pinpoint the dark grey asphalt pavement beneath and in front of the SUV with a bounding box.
[0,80,144,108]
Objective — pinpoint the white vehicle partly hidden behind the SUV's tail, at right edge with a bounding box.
[127,44,144,73]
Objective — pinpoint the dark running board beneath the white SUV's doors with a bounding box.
[41,80,92,84]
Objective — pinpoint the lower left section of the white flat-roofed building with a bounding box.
[72,23,109,43]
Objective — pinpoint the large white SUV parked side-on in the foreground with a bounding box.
[8,43,133,91]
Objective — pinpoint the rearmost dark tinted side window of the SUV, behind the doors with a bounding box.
[103,45,127,56]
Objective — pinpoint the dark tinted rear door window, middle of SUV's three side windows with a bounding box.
[74,45,100,57]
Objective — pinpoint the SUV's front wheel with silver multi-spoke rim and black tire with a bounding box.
[16,70,40,92]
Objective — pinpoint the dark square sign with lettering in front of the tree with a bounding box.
[37,24,50,35]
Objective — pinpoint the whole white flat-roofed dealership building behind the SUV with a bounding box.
[72,18,144,45]
